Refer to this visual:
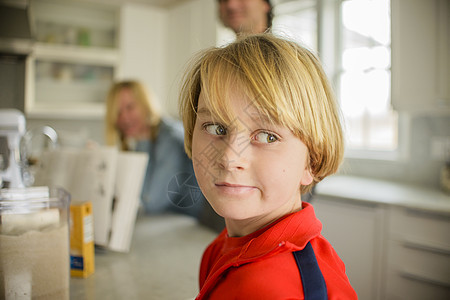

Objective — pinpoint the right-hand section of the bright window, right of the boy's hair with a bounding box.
[338,0,397,150]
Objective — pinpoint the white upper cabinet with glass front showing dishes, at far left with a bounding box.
[26,0,120,117]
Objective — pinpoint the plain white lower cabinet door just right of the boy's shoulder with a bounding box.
[312,196,384,299]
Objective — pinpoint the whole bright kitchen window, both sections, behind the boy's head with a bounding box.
[273,0,398,158]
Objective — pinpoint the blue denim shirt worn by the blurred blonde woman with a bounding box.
[136,119,206,217]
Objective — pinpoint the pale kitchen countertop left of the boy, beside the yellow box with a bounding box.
[70,215,217,300]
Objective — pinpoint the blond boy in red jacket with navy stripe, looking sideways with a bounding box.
[180,34,357,299]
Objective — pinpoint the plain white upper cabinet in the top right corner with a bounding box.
[391,0,450,113]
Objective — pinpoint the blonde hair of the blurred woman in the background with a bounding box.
[105,80,161,150]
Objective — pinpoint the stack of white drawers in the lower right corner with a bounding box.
[385,207,450,300]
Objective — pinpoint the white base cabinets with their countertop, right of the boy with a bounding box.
[312,175,450,300]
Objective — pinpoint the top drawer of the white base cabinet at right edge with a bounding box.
[389,207,450,248]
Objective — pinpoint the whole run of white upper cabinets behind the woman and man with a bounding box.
[25,0,216,119]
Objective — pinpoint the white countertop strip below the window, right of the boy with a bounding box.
[315,175,450,214]
